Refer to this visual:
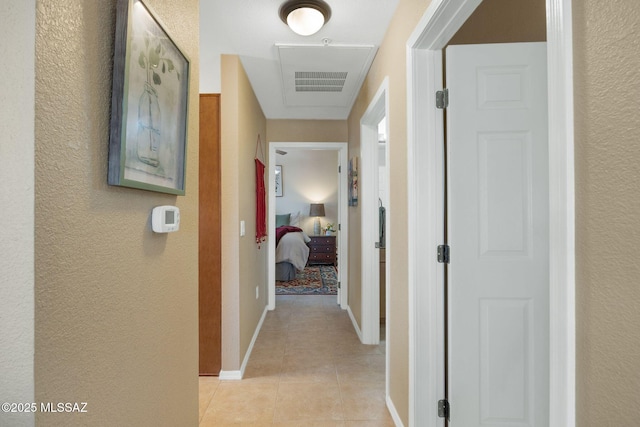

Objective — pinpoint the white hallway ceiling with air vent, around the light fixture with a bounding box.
[200,0,398,120]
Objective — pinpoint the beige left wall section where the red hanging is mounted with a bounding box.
[221,55,267,371]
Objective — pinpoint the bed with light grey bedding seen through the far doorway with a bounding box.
[276,213,311,282]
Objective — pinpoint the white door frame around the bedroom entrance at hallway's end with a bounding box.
[267,142,349,310]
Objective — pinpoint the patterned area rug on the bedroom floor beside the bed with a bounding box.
[276,265,338,295]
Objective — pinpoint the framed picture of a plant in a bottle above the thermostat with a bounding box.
[107,0,190,195]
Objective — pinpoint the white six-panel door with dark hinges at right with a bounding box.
[446,43,549,427]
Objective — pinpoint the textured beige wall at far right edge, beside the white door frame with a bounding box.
[573,0,640,427]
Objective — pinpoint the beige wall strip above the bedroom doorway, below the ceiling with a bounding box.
[267,120,348,142]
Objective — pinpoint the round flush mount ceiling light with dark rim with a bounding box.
[280,0,331,36]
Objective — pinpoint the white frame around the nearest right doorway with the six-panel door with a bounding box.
[407,0,576,427]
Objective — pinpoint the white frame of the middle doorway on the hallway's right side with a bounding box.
[358,77,391,346]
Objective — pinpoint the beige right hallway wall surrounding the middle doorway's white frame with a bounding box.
[349,0,430,425]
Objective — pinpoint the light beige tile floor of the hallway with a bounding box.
[200,295,394,427]
